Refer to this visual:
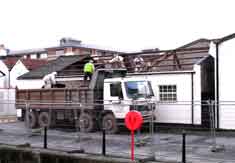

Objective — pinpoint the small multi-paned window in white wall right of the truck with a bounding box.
[159,85,177,102]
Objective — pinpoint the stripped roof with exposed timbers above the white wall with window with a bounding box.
[126,39,211,72]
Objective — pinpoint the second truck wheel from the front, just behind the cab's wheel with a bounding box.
[79,113,94,132]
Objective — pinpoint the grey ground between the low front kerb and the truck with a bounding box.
[0,122,235,163]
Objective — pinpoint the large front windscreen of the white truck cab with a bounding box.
[125,81,153,98]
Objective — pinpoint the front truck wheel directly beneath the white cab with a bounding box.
[102,114,118,134]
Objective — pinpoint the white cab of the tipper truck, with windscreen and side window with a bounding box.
[103,77,154,122]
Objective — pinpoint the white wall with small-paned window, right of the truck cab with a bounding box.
[127,73,201,124]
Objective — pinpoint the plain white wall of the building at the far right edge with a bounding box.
[219,39,235,129]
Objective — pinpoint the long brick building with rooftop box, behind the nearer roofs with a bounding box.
[8,38,121,60]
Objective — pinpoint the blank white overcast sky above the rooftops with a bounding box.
[0,0,235,51]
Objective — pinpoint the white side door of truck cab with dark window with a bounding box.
[104,82,125,119]
